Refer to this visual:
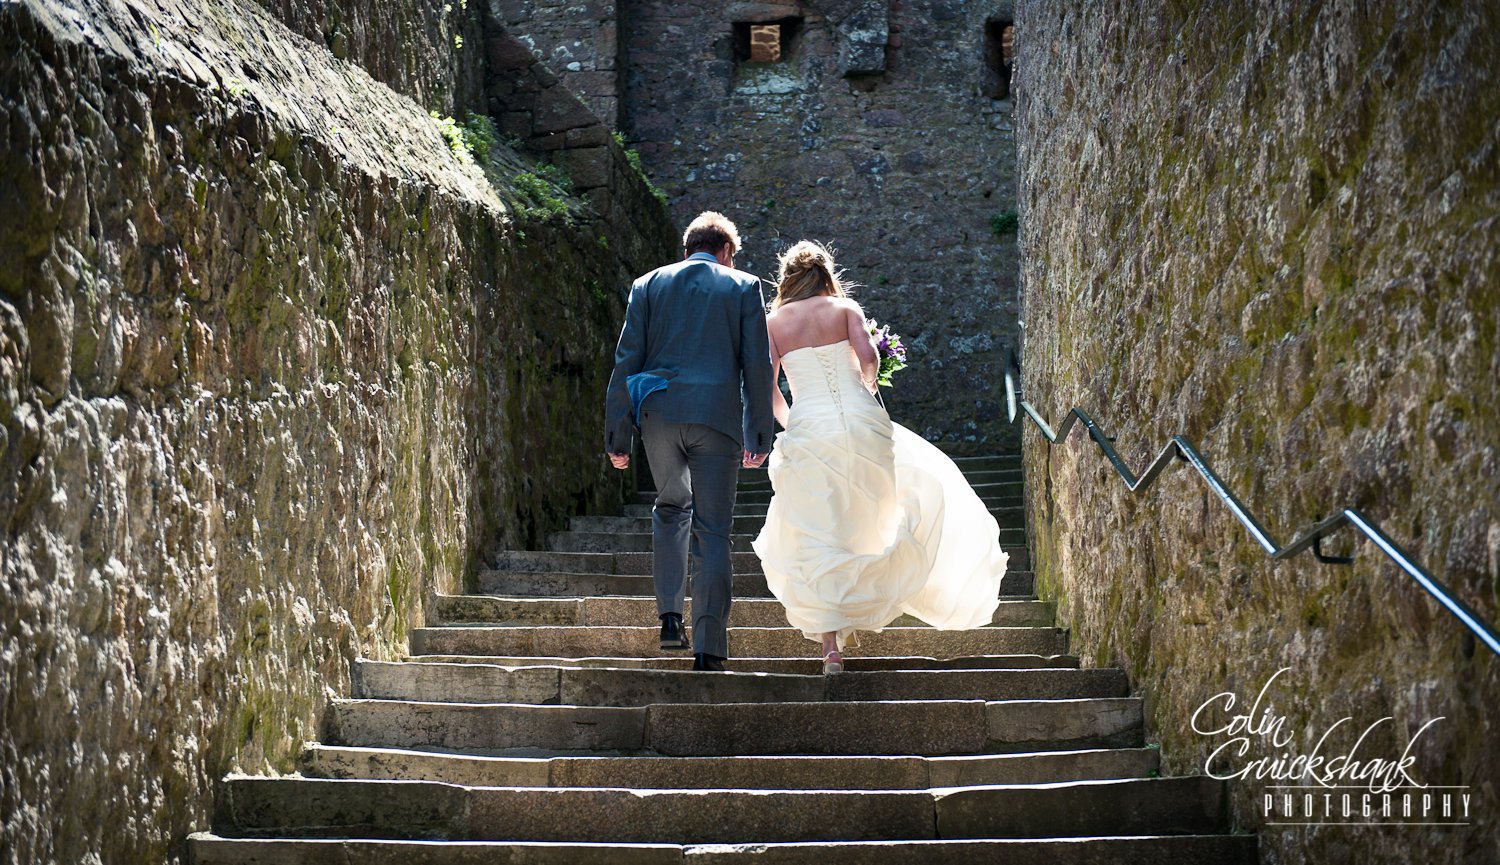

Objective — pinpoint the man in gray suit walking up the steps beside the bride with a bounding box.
[605,210,773,670]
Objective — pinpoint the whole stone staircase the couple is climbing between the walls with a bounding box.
[191,457,1257,865]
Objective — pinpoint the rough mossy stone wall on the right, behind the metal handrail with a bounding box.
[1017,0,1500,864]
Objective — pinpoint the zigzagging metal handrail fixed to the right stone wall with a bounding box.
[1005,349,1500,655]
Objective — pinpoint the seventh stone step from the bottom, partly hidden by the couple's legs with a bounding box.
[434,595,1058,628]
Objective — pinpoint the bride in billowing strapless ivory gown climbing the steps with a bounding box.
[753,240,1007,673]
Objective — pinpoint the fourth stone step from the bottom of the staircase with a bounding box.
[326,695,1143,757]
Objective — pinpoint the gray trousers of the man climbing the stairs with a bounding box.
[641,411,741,658]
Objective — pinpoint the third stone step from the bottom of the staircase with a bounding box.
[300,745,1161,790]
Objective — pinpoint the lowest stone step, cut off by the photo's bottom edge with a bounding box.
[188,834,1259,865]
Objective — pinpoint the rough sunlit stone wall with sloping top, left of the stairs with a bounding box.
[0,0,674,864]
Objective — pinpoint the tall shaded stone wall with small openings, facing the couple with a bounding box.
[495,0,1019,445]
